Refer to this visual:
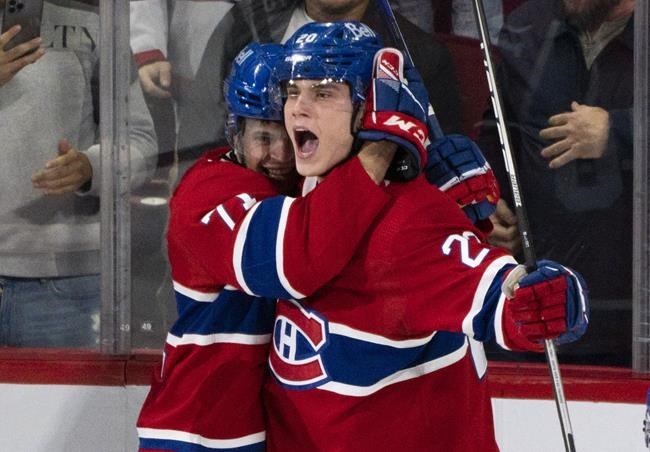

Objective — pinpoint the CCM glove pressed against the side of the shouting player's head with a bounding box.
[357,47,429,181]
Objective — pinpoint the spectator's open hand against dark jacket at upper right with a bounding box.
[539,102,609,168]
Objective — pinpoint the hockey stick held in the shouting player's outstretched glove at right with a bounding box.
[474,0,575,452]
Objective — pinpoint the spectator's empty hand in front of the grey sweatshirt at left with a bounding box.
[32,139,93,195]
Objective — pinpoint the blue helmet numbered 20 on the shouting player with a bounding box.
[278,21,383,102]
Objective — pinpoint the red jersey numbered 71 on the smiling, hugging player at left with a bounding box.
[137,149,389,452]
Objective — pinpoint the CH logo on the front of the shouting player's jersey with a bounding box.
[269,300,329,389]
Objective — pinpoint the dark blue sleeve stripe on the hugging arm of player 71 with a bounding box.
[241,196,294,299]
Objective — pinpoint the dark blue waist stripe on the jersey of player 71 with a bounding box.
[170,290,276,337]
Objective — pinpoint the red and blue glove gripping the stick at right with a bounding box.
[502,260,589,352]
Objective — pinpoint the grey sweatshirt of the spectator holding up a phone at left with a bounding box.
[0,0,157,277]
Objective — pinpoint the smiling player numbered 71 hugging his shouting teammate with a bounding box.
[137,40,402,452]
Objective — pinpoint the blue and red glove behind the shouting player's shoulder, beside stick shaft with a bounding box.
[424,135,499,228]
